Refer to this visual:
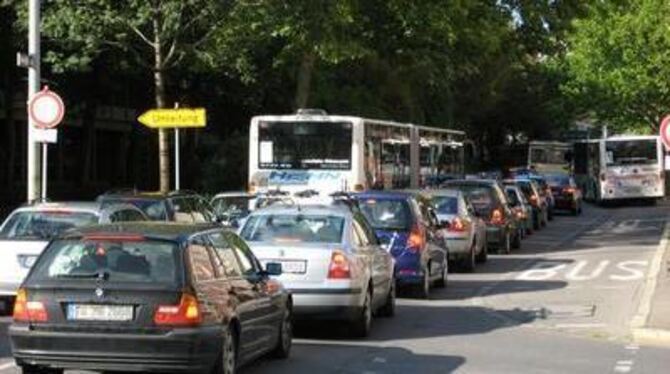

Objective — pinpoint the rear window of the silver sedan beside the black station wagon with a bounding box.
[241,213,344,243]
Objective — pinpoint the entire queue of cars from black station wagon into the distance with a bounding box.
[0,171,581,373]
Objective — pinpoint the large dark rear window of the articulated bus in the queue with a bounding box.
[258,121,353,170]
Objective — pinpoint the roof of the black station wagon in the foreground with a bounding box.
[60,221,223,242]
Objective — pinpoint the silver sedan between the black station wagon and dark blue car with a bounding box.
[240,205,395,337]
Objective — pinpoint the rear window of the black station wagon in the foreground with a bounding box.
[31,240,179,284]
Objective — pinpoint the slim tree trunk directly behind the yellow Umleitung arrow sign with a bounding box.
[154,15,170,192]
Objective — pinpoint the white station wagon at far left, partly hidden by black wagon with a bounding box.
[0,202,147,314]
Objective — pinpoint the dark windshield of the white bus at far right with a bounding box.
[606,139,658,166]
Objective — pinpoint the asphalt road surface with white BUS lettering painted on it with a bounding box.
[0,206,670,374]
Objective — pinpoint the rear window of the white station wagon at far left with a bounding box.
[0,210,98,240]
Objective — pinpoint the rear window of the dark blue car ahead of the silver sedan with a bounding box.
[359,198,412,231]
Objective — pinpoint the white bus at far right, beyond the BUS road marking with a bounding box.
[573,136,665,203]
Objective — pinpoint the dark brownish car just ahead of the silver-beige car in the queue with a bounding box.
[442,179,521,254]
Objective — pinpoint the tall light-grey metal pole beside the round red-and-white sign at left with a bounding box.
[26,0,41,201]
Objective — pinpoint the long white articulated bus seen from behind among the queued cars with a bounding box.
[249,110,465,193]
